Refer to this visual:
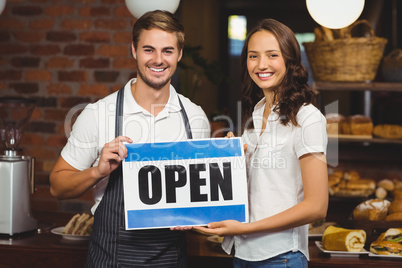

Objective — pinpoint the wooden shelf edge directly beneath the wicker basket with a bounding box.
[313,82,402,92]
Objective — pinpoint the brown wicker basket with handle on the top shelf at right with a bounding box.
[303,20,387,82]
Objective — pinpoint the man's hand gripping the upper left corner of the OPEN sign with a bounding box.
[97,136,133,177]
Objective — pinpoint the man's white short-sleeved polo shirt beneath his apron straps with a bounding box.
[61,78,210,213]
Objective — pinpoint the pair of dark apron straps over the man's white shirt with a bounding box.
[115,87,193,139]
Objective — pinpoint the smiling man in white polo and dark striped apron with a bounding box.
[50,11,210,267]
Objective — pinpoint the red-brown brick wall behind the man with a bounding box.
[0,0,136,214]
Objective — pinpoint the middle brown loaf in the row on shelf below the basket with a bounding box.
[342,115,373,136]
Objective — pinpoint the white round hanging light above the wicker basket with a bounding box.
[306,0,364,29]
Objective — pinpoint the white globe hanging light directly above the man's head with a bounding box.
[125,0,180,19]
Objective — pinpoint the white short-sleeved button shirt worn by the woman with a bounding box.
[222,99,327,261]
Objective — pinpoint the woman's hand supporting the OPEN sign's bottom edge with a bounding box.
[193,220,247,236]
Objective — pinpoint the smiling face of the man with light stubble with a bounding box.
[132,29,182,90]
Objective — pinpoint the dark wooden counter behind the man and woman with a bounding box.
[0,230,402,268]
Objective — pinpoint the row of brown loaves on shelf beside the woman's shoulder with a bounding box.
[325,113,402,143]
